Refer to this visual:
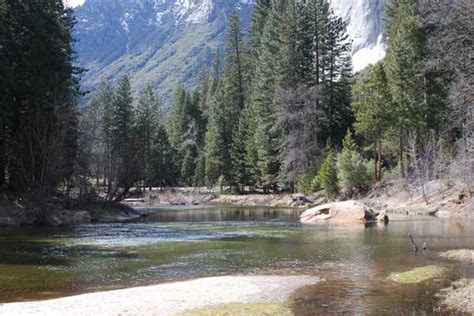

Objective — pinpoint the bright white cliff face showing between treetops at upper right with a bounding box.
[330,0,387,71]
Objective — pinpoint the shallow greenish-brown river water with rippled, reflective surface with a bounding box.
[0,206,474,315]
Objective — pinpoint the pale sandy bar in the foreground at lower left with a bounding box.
[0,276,319,316]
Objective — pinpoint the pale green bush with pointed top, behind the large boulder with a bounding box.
[337,131,371,195]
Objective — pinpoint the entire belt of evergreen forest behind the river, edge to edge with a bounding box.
[0,0,474,215]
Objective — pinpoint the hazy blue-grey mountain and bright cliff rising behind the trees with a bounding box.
[74,0,386,105]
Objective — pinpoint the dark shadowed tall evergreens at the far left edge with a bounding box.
[0,0,79,200]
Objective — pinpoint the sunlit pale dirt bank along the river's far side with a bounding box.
[125,180,474,217]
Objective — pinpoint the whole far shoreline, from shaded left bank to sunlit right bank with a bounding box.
[0,181,474,227]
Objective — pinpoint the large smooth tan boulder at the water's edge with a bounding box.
[300,200,378,224]
